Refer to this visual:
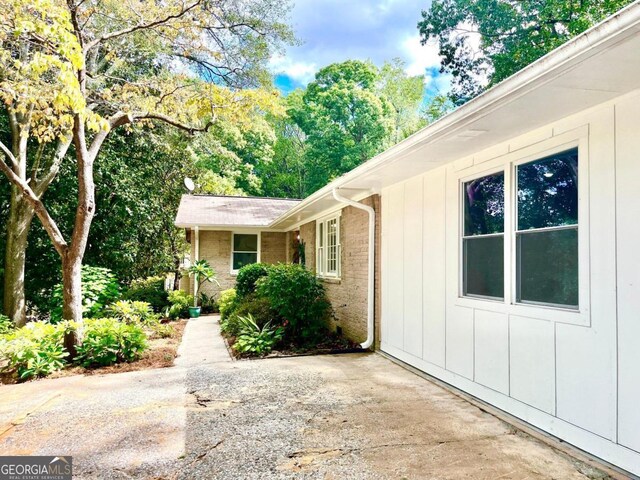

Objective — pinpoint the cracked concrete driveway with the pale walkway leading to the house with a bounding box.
[0,317,608,480]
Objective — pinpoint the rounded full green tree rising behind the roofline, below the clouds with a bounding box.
[289,60,393,193]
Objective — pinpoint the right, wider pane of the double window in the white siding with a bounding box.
[516,149,579,308]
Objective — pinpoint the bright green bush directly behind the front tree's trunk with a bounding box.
[51,265,120,322]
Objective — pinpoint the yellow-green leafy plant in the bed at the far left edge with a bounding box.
[0,322,69,380]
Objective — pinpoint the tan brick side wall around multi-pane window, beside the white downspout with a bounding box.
[300,195,380,348]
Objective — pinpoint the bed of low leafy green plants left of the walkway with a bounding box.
[0,300,183,383]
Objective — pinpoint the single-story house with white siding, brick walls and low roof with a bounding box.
[177,2,640,475]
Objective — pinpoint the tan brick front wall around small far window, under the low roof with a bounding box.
[188,230,287,295]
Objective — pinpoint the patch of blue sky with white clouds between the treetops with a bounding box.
[270,0,449,97]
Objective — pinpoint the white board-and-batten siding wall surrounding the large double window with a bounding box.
[381,92,640,475]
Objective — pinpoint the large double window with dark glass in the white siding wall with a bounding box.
[461,148,579,309]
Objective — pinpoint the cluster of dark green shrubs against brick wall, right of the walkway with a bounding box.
[219,263,357,357]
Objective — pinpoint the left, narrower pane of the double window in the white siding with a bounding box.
[462,172,504,299]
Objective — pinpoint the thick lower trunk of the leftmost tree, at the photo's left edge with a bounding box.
[4,186,34,327]
